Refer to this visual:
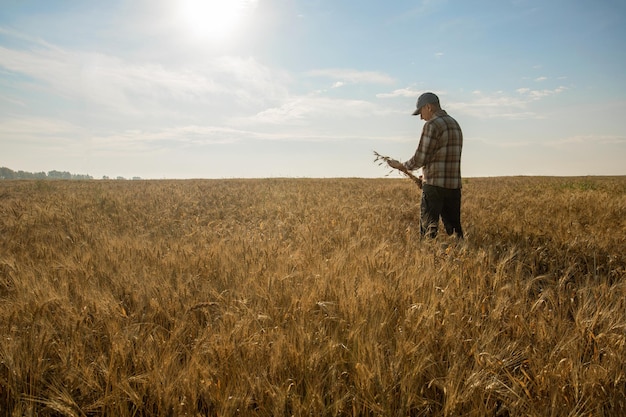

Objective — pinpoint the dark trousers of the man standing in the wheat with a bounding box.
[420,184,463,238]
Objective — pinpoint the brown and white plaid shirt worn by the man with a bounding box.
[404,110,463,189]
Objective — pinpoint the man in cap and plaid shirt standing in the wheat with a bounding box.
[389,93,463,239]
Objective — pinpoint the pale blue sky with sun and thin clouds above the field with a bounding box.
[0,0,626,179]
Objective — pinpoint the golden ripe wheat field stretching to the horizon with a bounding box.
[0,177,626,416]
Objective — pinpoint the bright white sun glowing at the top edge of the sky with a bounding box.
[180,0,256,41]
